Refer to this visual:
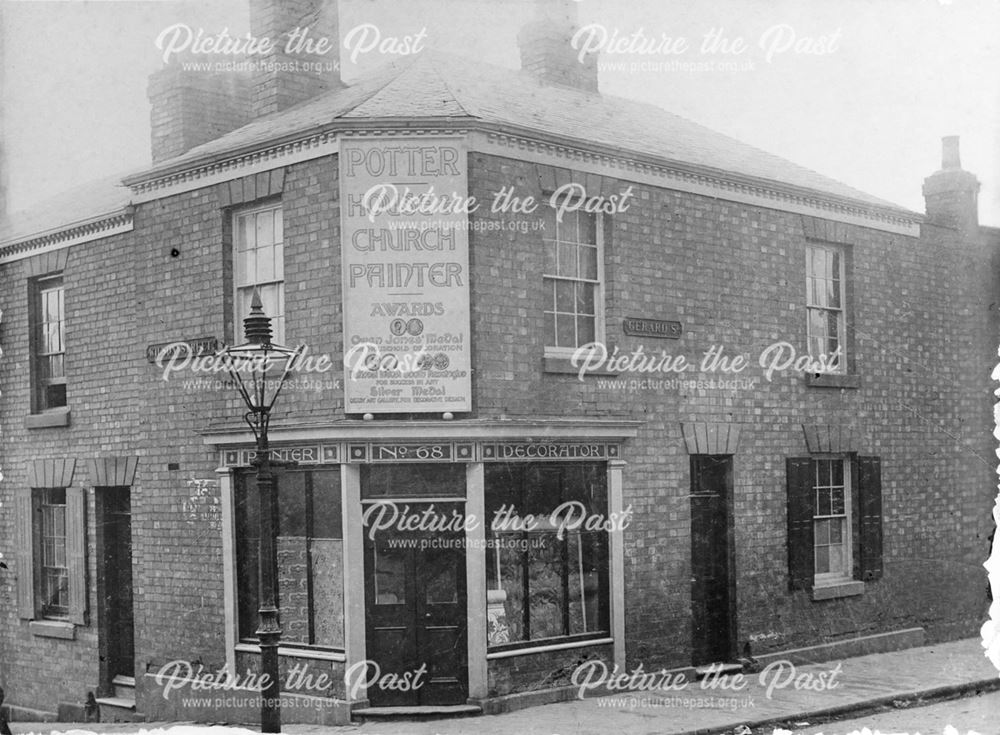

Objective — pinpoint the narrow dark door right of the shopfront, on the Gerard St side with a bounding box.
[691,454,735,666]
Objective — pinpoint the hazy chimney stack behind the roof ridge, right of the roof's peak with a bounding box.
[517,0,598,92]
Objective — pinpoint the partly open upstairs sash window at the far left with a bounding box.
[31,275,66,413]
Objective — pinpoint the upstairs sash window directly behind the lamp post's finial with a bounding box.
[239,203,285,344]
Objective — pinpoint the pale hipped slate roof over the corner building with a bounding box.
[136,51,914,215]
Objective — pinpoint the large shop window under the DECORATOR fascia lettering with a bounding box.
[485,462,610,647]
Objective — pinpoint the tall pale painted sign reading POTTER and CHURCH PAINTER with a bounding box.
[338,136,472,414]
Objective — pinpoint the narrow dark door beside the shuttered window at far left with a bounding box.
[102,487,135,679]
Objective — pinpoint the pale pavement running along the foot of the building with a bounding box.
[10,638,1000,735]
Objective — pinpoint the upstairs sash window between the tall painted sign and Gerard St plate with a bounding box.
[542,207,604,356]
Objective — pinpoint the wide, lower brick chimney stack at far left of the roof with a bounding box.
[147,67,250,164]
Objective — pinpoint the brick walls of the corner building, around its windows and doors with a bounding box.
[0,147,996,708]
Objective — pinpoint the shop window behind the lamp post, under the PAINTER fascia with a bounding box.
[235,467,344,648]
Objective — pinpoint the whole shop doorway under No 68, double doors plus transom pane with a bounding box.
[361,463,469,707]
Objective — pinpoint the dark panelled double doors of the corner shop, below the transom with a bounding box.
[365,503,468,707]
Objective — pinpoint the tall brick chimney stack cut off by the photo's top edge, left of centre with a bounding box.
[250,0,344,117]
